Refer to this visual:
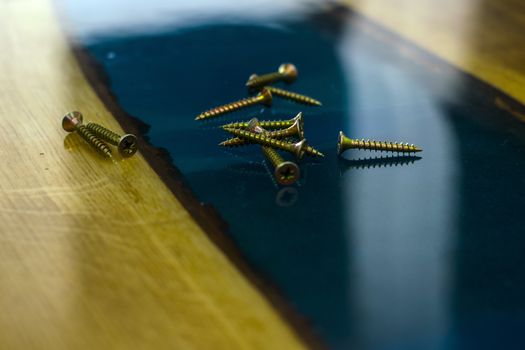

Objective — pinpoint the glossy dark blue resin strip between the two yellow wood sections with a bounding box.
[71,11,525,350]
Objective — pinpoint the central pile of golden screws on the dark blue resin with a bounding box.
[195,63,324,185]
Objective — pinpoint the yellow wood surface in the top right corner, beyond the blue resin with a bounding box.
[345,0,525,102]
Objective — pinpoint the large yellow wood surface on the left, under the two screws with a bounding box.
[0,0,303,350]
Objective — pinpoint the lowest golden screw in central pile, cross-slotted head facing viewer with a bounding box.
[248,118,301,185]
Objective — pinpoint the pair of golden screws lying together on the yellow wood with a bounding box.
[62,111,137,158]
